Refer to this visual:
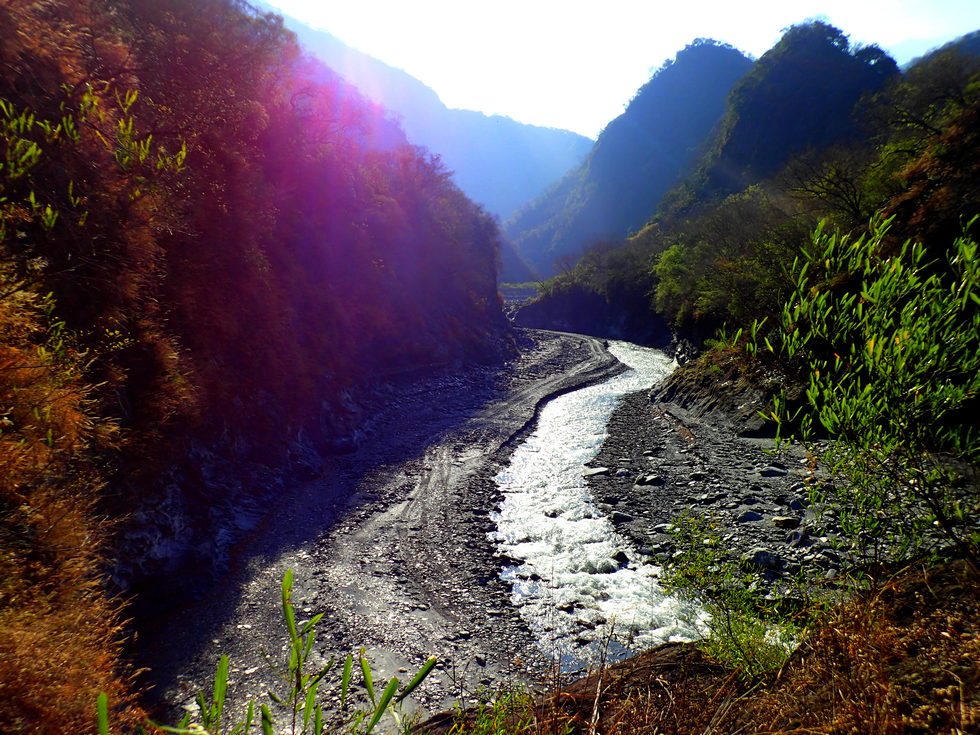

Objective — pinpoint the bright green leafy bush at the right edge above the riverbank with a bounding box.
[773,216,980,571]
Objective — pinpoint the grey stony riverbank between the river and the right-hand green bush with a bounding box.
[588,376,839,586]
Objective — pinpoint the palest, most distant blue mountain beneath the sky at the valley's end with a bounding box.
[264,4,592,230]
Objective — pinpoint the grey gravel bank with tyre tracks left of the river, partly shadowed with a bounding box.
[138,331,622,720]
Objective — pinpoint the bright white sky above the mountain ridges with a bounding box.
[258,0,980,138]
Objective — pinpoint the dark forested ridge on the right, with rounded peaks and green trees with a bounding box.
[517,22,980,343]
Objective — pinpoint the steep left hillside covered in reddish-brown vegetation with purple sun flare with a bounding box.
[0,0,509,733]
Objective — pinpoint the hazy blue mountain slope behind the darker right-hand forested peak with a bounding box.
[505,39,752,275]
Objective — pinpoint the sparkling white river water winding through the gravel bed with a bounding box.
[492,342,703,670]
